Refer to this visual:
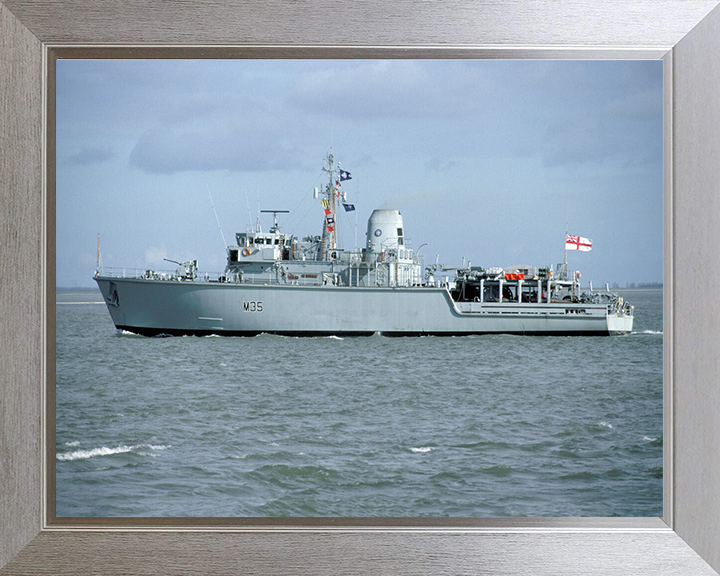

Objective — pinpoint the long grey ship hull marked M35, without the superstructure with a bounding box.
[95,275,632,336]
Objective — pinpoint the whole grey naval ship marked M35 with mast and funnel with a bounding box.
[94,154,633,336]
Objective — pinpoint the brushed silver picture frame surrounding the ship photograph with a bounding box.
[0,0,720,575]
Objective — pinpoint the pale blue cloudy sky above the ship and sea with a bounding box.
[56,60,663,287]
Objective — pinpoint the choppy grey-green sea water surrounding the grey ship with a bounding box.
[56,291,663,517]
